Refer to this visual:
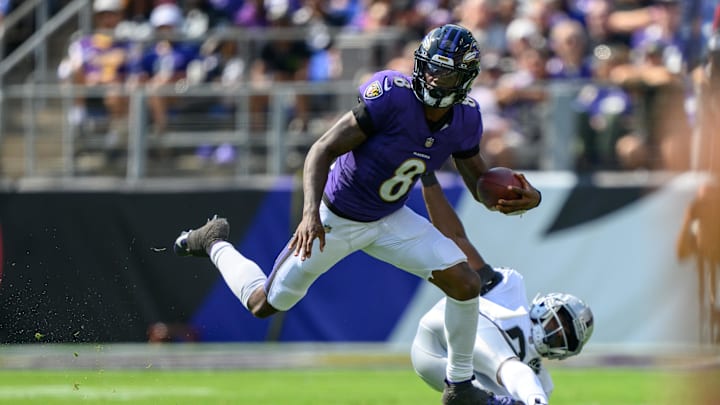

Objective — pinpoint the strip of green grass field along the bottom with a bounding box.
[0,368,708,405]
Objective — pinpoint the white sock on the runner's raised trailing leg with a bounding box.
[210,242,267,308]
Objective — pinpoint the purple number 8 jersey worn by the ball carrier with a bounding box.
[325,70,482,222]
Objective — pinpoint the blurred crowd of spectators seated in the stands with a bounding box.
[53,0,719,171]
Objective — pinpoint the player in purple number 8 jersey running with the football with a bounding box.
[174,24,540,404]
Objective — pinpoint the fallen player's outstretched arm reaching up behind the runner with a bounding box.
[420,172,486,270]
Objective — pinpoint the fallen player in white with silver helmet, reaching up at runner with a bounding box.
[411,173,593,405]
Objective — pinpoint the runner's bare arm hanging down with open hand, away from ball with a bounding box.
[288,111,367,259]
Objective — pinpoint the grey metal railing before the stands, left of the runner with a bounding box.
[3,81,357,180]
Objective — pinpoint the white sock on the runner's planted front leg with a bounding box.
[445,297,478,382]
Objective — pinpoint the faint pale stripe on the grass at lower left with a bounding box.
[0,384,217,401]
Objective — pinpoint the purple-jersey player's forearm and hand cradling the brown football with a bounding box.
[453,153,542,214]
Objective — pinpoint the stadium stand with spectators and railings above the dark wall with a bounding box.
[0,0,712,179]
